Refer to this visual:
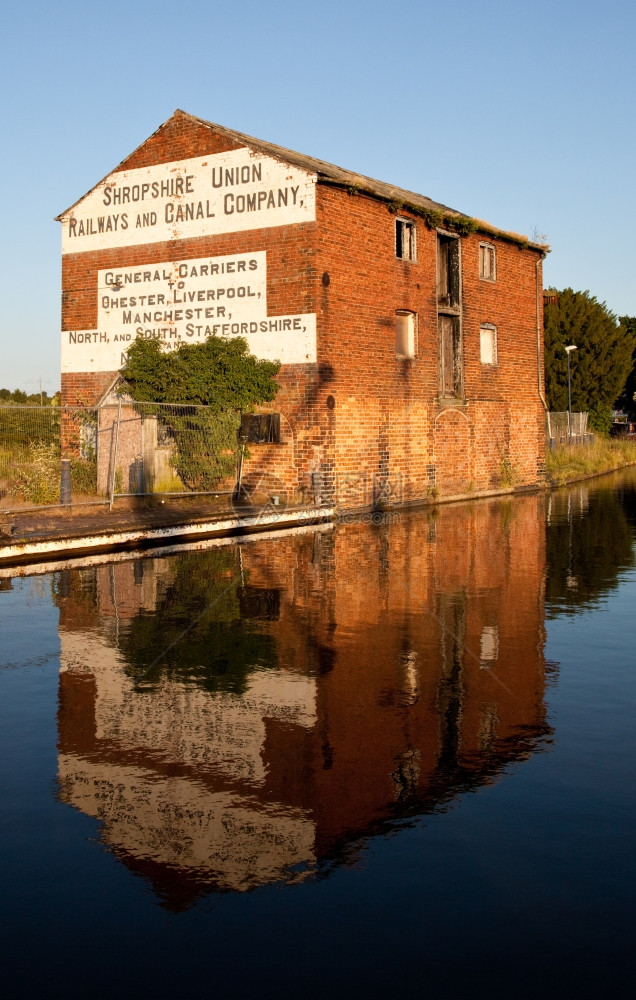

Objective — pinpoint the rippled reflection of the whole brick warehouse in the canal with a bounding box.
[59,497,547,905]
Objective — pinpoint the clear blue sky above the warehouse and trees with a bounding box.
[0,0,636,392]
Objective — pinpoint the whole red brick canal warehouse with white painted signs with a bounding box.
[58,111,547,508]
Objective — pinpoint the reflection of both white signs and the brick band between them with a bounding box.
[59,632,315,889]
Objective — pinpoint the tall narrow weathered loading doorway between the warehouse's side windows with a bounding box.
[437,233,463,399]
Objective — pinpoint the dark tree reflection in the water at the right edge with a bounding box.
[546,482,633,614]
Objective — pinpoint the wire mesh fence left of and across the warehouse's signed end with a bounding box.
[0,400,240,512]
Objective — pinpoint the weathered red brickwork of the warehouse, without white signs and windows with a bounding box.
[60,112,545,508]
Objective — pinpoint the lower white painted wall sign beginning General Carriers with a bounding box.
[62,250,316,372]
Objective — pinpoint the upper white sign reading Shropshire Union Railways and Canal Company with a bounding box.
[61,148,316,253]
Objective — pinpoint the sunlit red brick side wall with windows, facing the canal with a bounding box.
[316,186,544,503]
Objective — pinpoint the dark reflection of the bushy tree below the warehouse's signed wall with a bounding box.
[118,548,276,693]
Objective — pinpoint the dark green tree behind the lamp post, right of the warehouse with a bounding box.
[545,288,636,431]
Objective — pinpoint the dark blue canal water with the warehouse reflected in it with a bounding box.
[0,471,636,998]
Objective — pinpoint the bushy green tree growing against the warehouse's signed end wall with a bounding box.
[119,337,280,490]
